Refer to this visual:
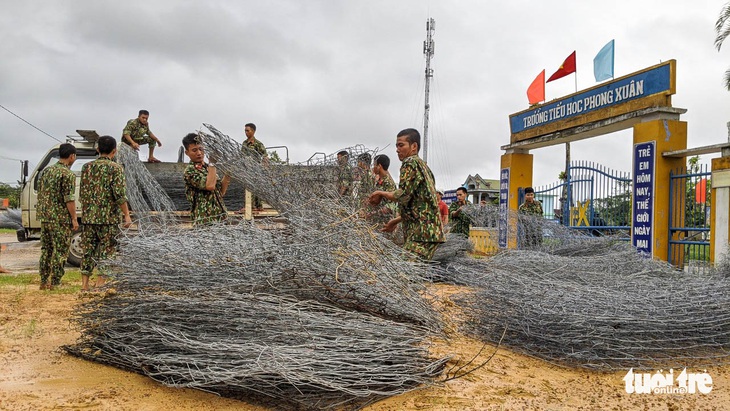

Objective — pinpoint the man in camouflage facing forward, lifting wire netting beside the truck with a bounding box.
[183,133,230,225]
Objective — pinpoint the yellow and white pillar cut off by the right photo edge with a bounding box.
[710,156,730,263]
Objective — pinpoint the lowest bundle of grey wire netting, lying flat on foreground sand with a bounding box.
[74,288,445,409]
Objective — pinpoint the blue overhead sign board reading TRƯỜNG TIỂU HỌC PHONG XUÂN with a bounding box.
[509,60,676,143]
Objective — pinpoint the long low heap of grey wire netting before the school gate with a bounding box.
[444,238,730,370]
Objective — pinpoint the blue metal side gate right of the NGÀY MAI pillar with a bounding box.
[667,164,712,271]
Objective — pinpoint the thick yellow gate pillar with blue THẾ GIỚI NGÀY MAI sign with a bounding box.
[631,120,687,261]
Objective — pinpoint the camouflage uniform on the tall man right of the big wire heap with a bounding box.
[394,155,444,260]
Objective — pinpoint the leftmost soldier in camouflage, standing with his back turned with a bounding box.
[38,143,79,290]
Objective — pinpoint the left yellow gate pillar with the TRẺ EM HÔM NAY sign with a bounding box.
[500,149,533,248]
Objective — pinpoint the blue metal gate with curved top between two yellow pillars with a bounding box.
[520,161,632,239]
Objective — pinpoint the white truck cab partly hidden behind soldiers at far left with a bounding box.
[17,130,99,266]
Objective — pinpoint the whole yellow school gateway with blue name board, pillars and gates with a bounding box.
[499,60,730,265]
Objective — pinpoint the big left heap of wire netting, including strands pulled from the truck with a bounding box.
[67,126,448,409]
